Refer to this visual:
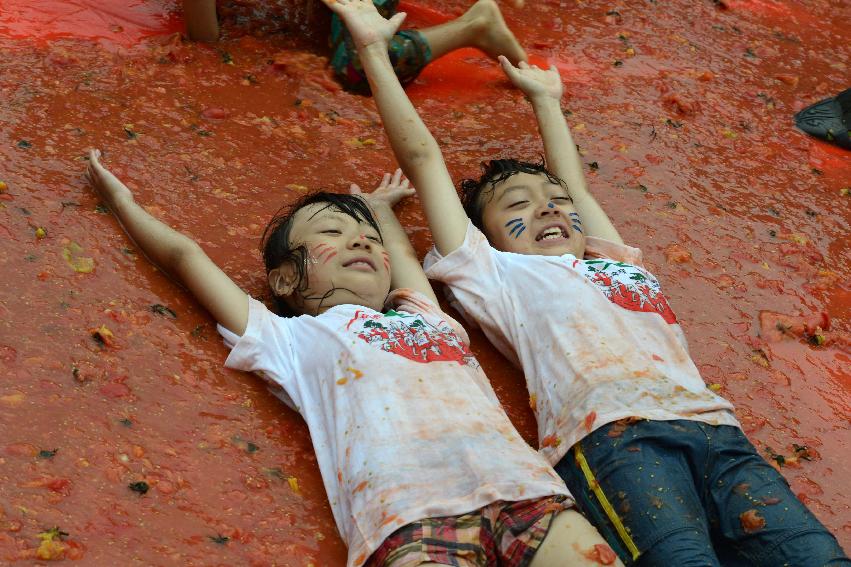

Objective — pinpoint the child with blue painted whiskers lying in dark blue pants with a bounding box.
[322,0,851,567]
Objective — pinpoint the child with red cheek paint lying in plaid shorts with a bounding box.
[87,152,616,567]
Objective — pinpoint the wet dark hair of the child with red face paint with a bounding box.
[260,191,384,317]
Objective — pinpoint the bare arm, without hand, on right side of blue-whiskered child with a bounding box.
[532,95,622,242]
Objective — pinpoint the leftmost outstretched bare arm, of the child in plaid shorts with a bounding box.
[86,150,248,335]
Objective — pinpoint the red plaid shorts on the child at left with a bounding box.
[366,496,567,567]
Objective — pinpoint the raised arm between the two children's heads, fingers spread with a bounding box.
[350,169,437,304]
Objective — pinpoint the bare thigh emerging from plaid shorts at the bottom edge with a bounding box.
[530,510,623,567]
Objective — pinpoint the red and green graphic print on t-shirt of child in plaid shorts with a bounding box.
[346,310,478,366]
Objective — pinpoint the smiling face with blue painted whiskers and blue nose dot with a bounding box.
[482,173,585,258]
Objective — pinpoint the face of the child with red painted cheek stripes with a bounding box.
[280,203,390,315]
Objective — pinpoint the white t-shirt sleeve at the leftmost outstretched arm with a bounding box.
[216,297,298,410]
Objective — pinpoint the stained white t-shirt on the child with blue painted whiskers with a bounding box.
[425,223,739,464]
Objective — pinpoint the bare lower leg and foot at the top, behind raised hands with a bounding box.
[414,0,526,65]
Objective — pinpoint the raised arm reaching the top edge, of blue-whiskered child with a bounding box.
[323,0,468,255]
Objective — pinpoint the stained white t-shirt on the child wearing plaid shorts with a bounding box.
[219,290,569,566]
